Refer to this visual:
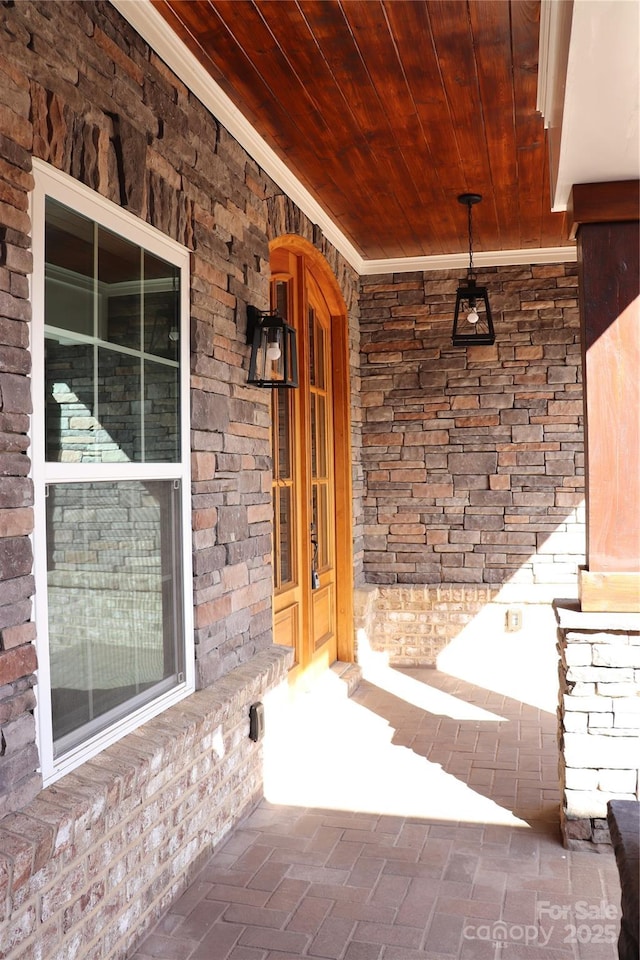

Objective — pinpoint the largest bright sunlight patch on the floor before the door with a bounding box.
[264,671,527,827]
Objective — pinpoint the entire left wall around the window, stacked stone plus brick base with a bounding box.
[0,0,362,960]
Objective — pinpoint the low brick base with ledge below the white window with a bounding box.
[0,647,290,960]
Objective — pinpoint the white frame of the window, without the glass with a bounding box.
[30,159,195,786]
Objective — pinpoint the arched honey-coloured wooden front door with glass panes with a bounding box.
[271,239,353,680]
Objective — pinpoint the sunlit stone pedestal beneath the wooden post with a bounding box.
[555,601,640,850]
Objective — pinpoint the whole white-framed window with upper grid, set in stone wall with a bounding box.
[31,161,194,784]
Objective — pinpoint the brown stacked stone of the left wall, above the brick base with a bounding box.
[0,2,361,813]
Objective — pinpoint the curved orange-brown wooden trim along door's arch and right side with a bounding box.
[269,234,355,663]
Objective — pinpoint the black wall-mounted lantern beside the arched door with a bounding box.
[247,307,298,387]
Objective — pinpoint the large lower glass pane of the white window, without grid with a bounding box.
[47,481,184,755]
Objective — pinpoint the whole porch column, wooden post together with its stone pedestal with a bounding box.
[555,181,640,849]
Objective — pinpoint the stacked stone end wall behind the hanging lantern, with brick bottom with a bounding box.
[360,263,585,663]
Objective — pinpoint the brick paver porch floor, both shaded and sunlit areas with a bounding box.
[132,668,620,960]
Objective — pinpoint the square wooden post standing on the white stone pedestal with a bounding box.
[572,181,640,612]
